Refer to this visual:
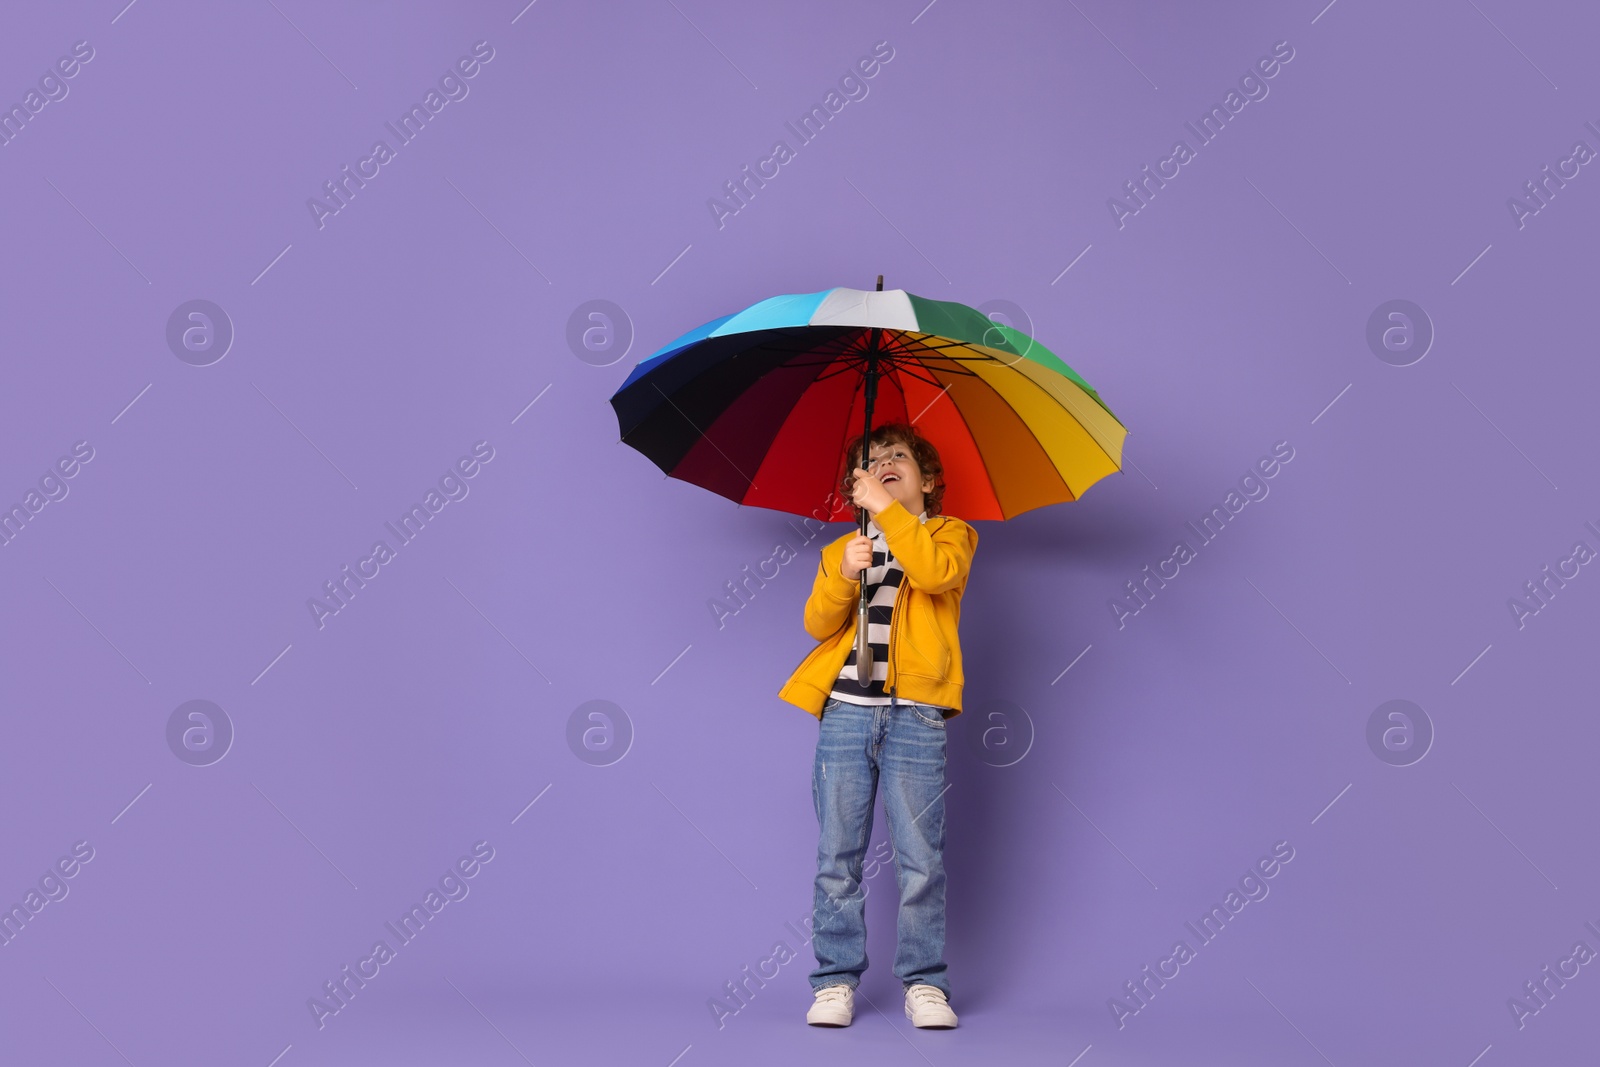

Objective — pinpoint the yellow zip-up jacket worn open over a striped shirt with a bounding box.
[778,501,978,718]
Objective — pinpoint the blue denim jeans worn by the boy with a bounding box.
[811,697,950,997]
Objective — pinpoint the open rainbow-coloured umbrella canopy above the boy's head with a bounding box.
[611,281,1128,522]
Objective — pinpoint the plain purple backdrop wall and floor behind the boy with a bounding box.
[0,0,1600,1067]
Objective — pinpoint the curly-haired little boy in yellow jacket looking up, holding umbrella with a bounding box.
[779,422,978,1029]
